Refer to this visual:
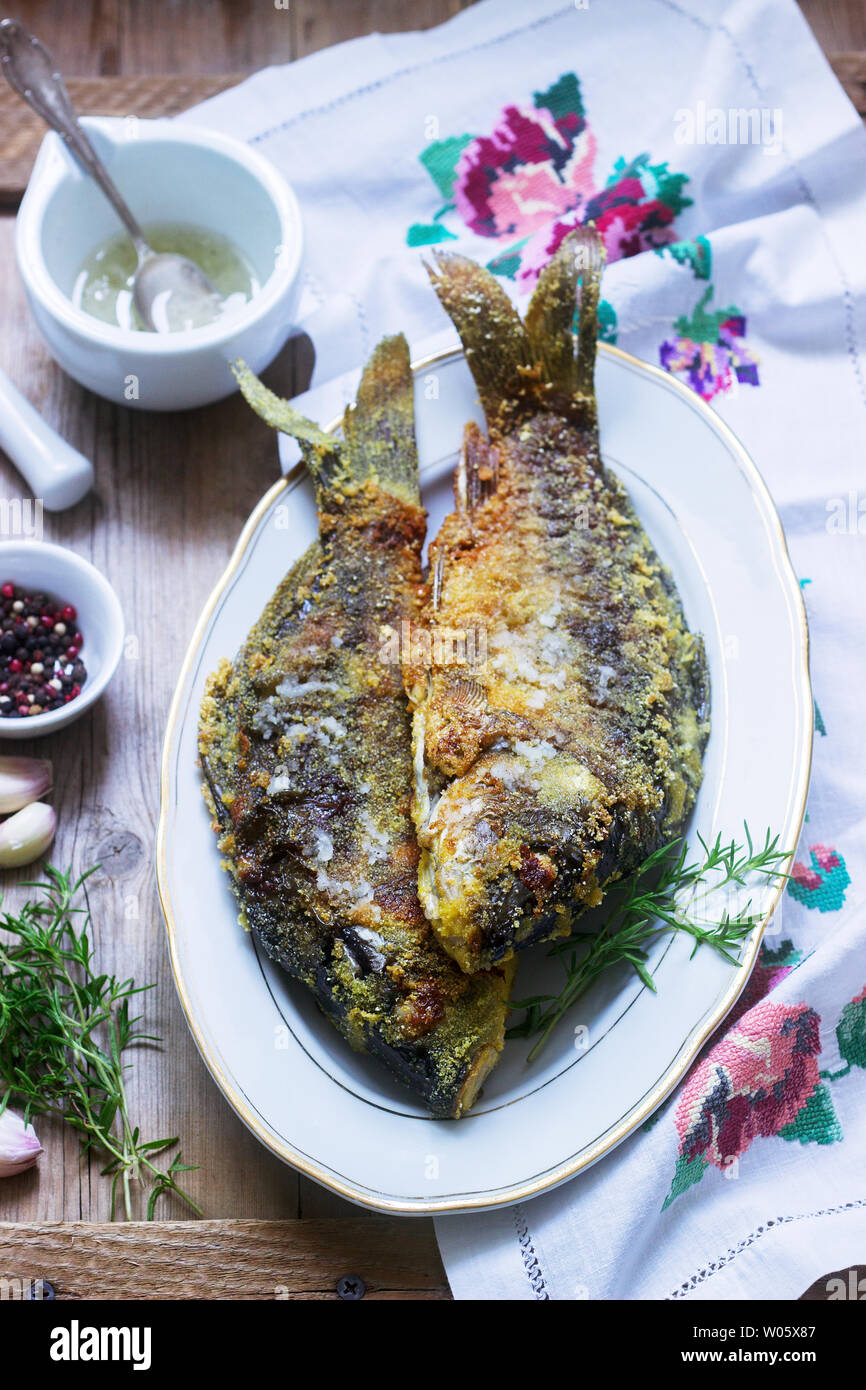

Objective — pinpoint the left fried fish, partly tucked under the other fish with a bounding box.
[199,338,510,1116]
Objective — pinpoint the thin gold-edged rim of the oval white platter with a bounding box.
[156,343,813,1216]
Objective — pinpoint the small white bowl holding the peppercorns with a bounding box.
[0,541,124,741]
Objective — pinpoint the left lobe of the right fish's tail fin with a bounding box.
[427,252,531,424]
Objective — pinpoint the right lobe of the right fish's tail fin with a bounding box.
[525,222,605,413]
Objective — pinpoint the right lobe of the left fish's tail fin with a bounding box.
[343,334,420,505]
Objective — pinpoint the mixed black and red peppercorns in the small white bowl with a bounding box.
[0,582,88,719]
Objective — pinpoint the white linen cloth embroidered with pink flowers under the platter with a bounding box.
[185,0,866,1300]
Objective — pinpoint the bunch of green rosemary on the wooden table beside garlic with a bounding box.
[0,866,202,1220]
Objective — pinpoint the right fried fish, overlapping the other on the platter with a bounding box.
[405,228,709,972]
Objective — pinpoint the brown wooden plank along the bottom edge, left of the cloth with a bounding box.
[0,1215,450,1300]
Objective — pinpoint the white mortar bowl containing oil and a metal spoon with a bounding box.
[15,117,303,410]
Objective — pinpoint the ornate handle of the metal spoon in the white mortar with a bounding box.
[0,19,150,261]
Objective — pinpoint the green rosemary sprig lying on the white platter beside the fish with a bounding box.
[506,826,790,1062]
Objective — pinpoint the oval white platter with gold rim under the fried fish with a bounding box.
[157,346,813,1213]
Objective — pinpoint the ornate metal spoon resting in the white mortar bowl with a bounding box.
[0,19,221,332]
